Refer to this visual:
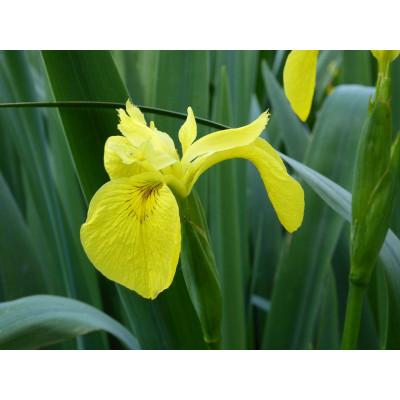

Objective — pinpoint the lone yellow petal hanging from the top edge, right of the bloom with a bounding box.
[283,50,318,121]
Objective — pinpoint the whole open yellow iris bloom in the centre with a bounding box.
[81,101,304,299]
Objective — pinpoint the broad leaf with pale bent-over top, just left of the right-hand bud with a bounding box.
[264,86,372,349]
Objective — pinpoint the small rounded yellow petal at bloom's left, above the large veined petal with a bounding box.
[104,136,146,179]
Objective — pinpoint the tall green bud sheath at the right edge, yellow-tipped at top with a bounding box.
[350,54,399,285]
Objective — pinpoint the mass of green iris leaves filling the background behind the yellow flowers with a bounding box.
[0,51,400,349]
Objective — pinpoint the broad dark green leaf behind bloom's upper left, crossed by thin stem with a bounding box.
[43,51,128,199]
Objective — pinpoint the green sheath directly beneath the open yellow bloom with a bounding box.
[180,191,222,347]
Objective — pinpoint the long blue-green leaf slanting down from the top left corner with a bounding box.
[0,51,76,296]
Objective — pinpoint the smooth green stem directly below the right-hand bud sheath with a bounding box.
[342,281,367,350]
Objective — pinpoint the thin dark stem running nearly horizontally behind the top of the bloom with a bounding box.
[0,101,230,129]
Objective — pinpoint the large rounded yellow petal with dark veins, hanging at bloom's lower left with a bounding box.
[81,173,181,299]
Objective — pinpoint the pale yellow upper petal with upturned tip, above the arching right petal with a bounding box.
[182,111,269,164]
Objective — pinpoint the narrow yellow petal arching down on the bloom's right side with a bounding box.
[186,138,304,232]
